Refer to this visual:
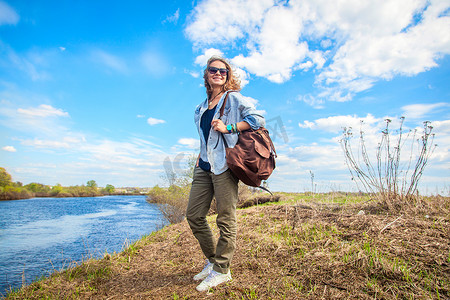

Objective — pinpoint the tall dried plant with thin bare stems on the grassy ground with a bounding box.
[340,117,437,201]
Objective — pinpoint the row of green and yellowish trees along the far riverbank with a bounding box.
[0,167,115,200]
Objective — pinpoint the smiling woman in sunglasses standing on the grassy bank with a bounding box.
[186,56,265,291]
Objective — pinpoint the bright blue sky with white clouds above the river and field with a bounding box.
[0,0,450,194]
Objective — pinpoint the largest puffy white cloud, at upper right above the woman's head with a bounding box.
[185,0,450,101]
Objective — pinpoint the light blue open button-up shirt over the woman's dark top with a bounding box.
[194,92,265,175]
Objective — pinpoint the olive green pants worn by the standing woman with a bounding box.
[186,167,239,274]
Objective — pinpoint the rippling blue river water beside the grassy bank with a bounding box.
[0,196,166,297]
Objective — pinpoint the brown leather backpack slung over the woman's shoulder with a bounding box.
[220,93,277,194]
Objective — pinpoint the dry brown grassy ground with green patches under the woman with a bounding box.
[7,193,450,299]
